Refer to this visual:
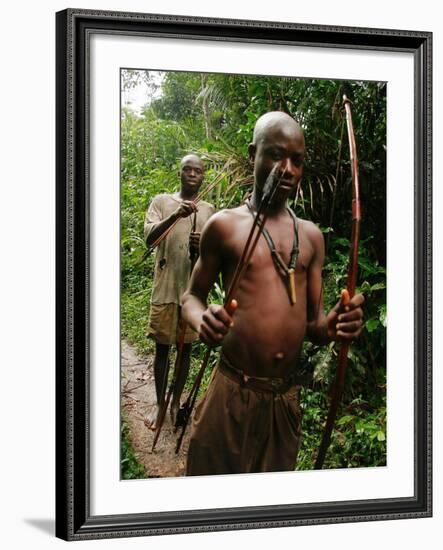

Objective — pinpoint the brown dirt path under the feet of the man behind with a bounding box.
[121,341,190,477]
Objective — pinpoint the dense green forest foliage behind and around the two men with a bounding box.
[121,71,386,469]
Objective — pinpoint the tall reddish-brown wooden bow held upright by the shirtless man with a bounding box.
[314,95,361,470]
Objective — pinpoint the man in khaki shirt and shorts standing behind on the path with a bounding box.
[144,154,215,429]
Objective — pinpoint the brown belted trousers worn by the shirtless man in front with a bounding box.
[186,354,301,476]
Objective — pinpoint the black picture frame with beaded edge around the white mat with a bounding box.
[56,9,432,540]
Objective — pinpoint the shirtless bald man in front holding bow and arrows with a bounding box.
[182,112,364,475]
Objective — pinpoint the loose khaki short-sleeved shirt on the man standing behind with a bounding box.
[144,194,215,304]
